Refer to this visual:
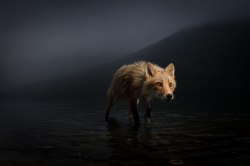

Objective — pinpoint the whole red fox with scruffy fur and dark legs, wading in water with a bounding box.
[105,61,176,124]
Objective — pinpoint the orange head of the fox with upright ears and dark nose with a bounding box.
[144,62,176,101]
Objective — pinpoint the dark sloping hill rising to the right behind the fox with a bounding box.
[5,21,250,109]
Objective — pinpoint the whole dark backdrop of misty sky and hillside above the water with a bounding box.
[0,0,250,111]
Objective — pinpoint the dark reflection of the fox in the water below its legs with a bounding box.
[104,117,169,165]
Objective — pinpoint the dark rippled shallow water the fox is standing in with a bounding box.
[0,101,250,166]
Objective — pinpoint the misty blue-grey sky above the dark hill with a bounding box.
[0,0,250,90]
